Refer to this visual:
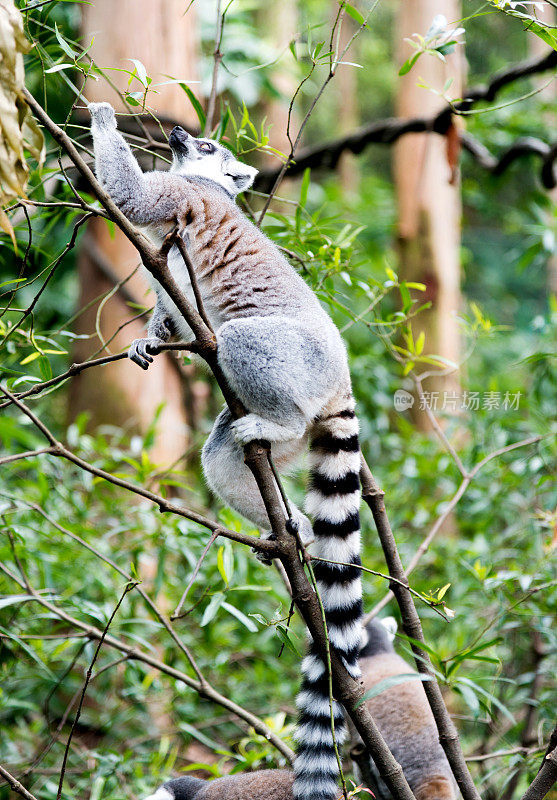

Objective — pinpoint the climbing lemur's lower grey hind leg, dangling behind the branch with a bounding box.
[201,408,313,552]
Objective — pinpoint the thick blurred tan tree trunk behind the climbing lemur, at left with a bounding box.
[70,0,197,464]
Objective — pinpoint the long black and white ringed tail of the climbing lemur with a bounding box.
[294,397,362,800]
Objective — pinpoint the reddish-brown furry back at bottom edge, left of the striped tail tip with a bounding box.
[200,769,294,800]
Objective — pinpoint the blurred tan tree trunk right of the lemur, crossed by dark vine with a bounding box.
[394,0,464,429]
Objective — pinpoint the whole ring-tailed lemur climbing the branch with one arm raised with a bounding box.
[89,103,362,800]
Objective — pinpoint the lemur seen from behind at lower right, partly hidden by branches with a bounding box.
[350,620,458,800]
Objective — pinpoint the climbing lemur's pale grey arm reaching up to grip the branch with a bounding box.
[89,103,189,225]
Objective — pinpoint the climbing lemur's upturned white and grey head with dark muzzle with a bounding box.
[168,125,257,197]
